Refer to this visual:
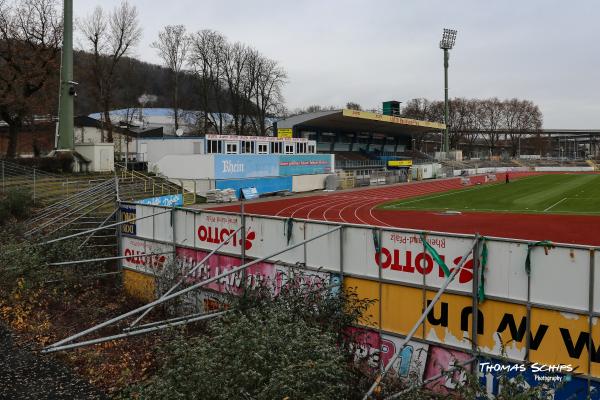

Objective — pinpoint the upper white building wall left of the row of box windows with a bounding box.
[140,137,204,171]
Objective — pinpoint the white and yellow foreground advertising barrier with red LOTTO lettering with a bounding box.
[121,200,600,390]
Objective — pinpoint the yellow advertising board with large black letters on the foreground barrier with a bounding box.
[344,278,600,377]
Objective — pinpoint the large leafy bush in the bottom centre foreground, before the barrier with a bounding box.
[134,284,371,400]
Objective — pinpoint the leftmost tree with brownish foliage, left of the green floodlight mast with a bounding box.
[0,0,62,157]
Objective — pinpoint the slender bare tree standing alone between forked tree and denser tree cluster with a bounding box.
[152,25,190,130]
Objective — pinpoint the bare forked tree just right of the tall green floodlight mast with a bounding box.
[78,0,142,142]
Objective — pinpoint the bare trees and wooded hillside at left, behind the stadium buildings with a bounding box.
[0,0,287,157]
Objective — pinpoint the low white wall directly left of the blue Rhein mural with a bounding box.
[154,154,215,179]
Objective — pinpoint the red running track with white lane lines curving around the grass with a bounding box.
[211,172,600,246]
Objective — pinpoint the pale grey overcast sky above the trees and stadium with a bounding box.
[74,0,600,129]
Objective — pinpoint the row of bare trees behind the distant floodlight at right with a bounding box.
[401,97,543,157]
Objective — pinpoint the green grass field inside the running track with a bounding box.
[380,174,600,215]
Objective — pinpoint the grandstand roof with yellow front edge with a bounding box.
[277,109,446,135]
